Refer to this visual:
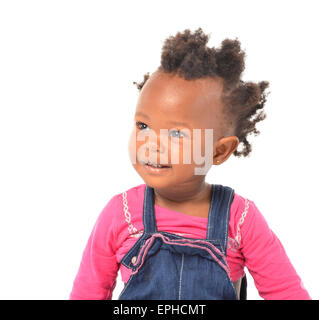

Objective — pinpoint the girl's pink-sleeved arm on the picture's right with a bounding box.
[240,201,311,300]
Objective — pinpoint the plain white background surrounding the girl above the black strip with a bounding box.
[0,0,319,299]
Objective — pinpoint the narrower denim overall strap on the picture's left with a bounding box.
[143,185,157,234]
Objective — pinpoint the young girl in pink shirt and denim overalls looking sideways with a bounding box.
[70,28,310,300]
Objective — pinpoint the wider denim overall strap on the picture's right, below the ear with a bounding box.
[206,184,234,253]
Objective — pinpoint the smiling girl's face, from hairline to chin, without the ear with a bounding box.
[129,71,230,188]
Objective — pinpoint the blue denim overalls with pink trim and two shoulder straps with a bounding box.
[119,184,245,300]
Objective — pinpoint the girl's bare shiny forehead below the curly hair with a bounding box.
[136,71,223,128]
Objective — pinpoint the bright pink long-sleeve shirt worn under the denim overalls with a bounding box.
[69,184,311,300]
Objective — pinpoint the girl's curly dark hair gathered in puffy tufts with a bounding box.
[133,28,269,157]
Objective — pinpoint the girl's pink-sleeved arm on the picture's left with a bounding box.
[69,196,119,300]
